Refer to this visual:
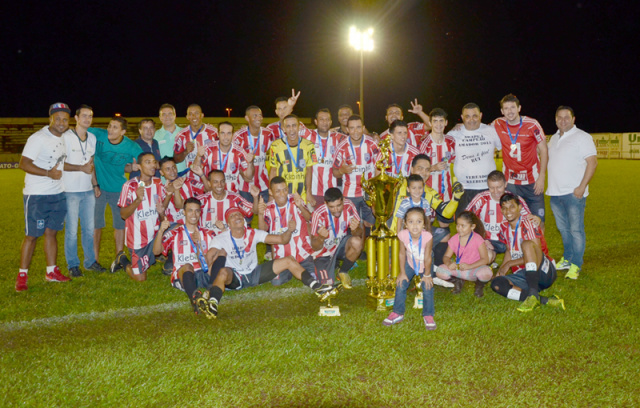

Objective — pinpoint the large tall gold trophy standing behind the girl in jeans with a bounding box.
[362,138,404,310]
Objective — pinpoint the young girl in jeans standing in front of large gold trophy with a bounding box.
[382,207,436,330]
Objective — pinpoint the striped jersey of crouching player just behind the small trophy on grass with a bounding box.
[311,198,360,258]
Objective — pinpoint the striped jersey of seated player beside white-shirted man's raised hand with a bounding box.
[264,194,313,262]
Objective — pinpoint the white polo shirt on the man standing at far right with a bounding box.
[547,126,598,197]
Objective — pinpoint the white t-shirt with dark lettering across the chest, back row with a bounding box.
[449,123,502,190]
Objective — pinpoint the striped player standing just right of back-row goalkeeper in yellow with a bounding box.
[309,109,342,205]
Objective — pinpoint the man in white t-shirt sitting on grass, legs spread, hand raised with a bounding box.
[198,208,332,317]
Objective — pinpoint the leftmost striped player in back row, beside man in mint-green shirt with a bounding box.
[173,104,218,178]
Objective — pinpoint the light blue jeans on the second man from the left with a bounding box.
[64,190,96,269]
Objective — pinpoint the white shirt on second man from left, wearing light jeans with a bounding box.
[62,130,96,193]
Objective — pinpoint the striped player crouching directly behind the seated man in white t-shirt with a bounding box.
[197,169,259,235]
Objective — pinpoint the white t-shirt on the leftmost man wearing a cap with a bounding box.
[22,126,73,195]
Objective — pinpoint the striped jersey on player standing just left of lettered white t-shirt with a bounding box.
[420,135,456,201]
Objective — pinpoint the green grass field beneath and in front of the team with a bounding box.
[0,160,640,407]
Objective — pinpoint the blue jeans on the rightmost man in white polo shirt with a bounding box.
[550,193,587,268]
